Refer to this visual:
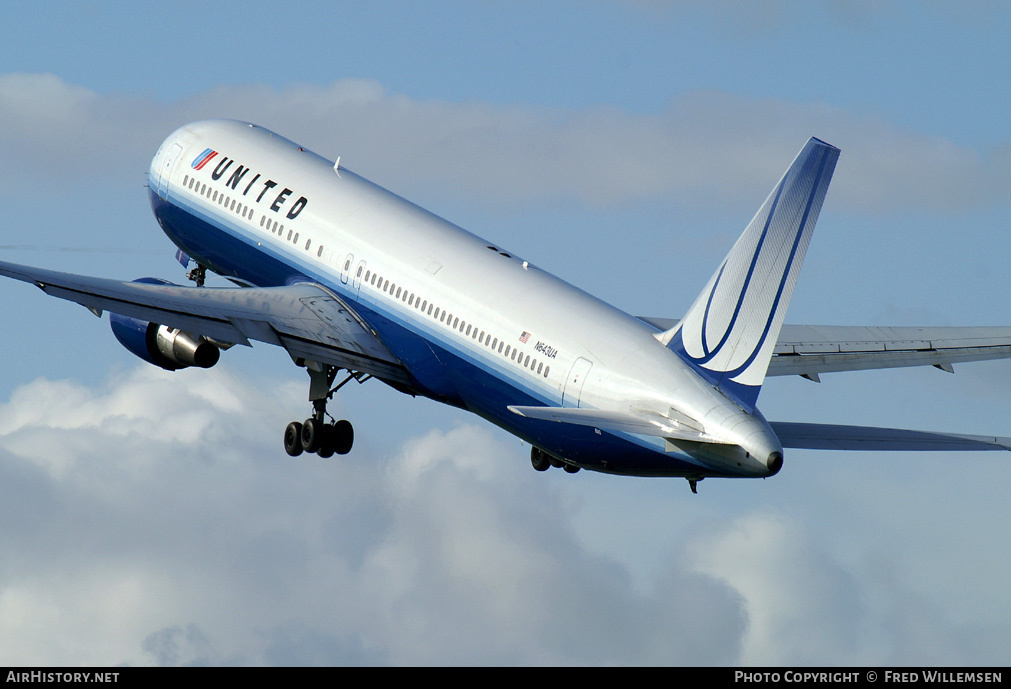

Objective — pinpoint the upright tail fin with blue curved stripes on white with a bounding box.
[659,138,839,410]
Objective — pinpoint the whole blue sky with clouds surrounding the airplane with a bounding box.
[0,0,1011,665]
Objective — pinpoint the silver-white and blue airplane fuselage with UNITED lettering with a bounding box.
[151,120,783,477]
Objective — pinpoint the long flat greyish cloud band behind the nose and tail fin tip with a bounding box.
[0,74,1009,212]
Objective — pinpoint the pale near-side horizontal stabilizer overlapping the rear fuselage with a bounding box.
[509,406,720,442]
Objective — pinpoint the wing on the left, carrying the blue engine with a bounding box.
[0,262,410,385]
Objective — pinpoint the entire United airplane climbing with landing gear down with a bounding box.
[0,120,1011,491]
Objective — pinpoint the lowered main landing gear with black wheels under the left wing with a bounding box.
[284,362,371,458]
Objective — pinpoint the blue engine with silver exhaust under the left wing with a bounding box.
[109,278,221,371]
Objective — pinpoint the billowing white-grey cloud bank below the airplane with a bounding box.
[0,367,1008,665]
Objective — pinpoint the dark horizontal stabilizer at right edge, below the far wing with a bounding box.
[769,421,1011,452]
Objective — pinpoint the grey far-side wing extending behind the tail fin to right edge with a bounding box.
[641,318,1011,381]
